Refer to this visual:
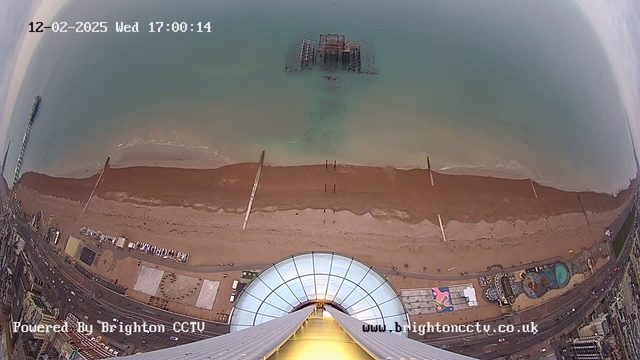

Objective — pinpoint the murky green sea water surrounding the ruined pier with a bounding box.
[5,0,636,191]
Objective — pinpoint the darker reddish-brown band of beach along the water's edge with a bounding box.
[18,163,636,224]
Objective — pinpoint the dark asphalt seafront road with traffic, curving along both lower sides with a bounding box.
[28,219,631,359]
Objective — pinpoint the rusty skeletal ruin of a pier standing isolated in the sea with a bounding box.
[285,34,378,75]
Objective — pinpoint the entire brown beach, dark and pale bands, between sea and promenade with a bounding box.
[13,164,632,273]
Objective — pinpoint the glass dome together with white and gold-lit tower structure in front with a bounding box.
[119,252,471,360]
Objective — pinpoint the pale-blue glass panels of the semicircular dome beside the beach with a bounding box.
[229,252,409,336]
